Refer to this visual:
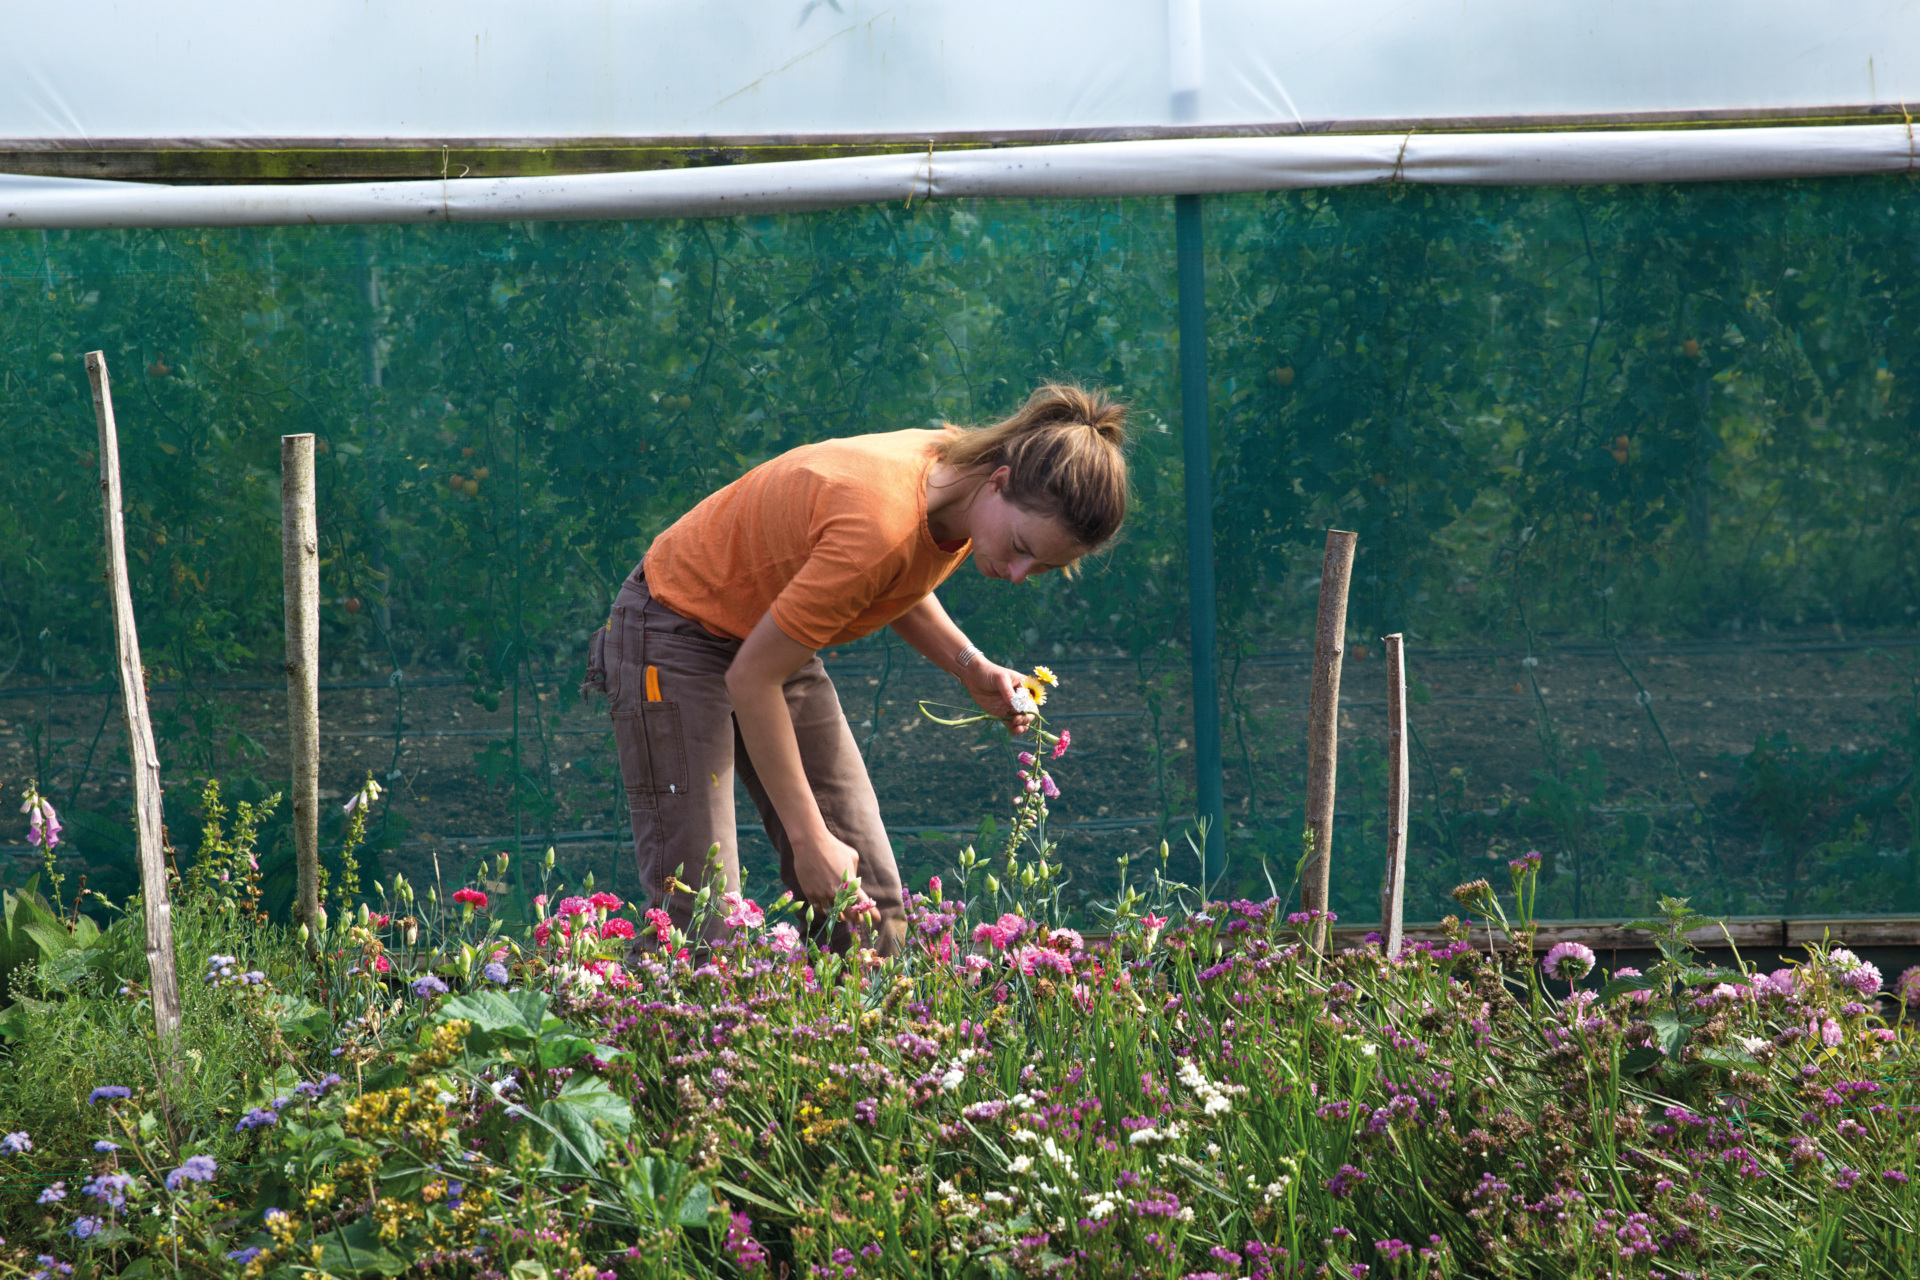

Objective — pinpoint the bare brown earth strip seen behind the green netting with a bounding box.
[0,631,1914,910]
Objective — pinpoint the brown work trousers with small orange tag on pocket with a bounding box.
[588,564,906,956]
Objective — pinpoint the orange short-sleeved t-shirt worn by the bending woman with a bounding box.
[641,428,972,649]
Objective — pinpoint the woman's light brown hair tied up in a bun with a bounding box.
[941,382,1127,551]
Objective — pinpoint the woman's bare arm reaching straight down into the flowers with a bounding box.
[726,612,879,921]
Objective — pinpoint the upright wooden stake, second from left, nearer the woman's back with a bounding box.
[280,436,321,936]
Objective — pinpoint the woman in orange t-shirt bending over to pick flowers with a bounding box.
[589,386,1127,954]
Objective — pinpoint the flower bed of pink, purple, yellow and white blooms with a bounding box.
[0,733,1920,1280]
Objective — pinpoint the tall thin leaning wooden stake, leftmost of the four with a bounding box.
[86,351,180,1061]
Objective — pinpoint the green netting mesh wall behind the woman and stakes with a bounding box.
[0,178,1920,921]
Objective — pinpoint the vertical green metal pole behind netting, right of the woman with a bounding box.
[1173,196,1227,885]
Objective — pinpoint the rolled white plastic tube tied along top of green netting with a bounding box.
[0,125,1920,228]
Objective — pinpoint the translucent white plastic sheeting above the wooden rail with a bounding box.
[0,0,1920,142]
